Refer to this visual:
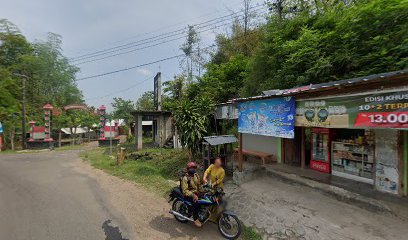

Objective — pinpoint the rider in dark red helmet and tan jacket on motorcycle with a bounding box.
[181,162,203,227]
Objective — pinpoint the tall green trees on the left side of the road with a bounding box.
[0,19,83,149]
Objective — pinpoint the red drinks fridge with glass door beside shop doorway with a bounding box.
[310,128,332,173]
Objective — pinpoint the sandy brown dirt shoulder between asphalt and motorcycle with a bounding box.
[73,154,222,240]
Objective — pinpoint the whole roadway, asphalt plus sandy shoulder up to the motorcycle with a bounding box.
[0,146,220,240]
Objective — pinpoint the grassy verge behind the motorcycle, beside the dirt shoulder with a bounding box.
[80,148,188,196]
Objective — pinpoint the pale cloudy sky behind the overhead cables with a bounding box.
[0,0,264,111]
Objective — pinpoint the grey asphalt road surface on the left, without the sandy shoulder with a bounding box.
[0,150,132,240]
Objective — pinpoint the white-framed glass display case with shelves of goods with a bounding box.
[331,142,374,184]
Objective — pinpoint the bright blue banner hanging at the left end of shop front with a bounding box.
[238,97,295,138]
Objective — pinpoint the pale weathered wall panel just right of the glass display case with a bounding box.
[375,129,400,194]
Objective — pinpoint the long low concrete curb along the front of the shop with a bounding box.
[264,169,395,214]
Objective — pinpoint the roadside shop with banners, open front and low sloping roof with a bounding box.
[233,71,408,195]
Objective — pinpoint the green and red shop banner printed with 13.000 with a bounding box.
[295,91,408,128]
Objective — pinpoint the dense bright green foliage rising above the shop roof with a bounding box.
[243,0,408,96]
